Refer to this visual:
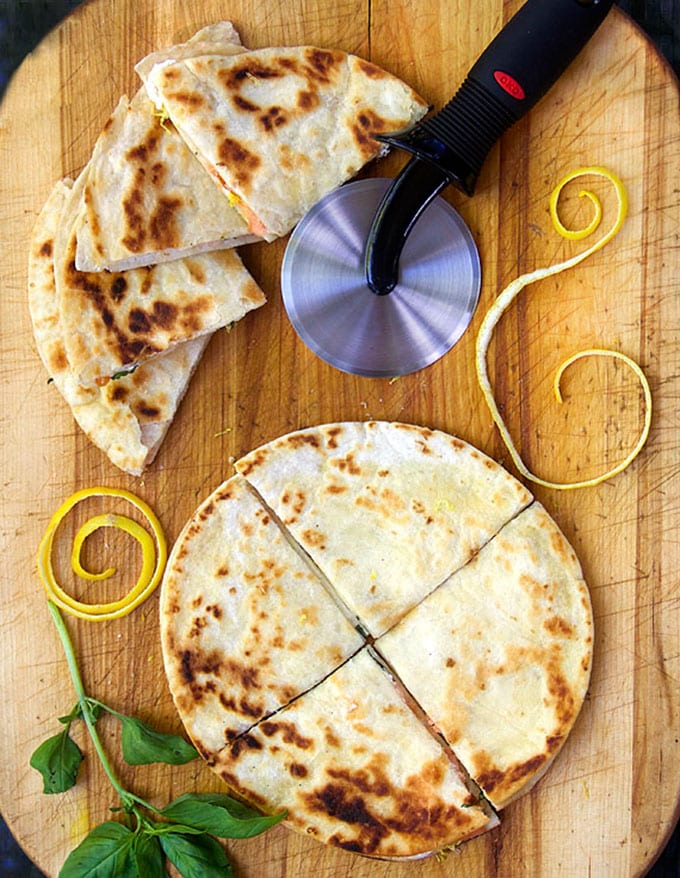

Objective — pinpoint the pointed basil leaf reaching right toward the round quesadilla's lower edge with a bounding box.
[161,793,286,838]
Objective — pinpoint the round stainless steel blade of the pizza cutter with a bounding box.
[281,178,481,378]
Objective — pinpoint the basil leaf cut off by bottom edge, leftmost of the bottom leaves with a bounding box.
[59,820,137,878]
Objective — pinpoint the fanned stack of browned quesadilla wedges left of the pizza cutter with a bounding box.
[29,22,426,474]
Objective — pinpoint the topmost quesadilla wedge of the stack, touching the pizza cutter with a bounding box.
[137,46,427,240]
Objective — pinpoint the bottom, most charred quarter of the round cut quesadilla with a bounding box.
[212,650,498,859]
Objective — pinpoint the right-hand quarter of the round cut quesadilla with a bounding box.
[376,503,593,809]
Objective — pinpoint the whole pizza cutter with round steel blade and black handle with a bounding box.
[281,0,613,377]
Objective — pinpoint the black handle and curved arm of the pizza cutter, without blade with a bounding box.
[365,0,613,295]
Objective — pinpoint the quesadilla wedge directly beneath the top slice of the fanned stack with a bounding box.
[76,22,257,271]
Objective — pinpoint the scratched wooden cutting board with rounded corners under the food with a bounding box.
[0,0,680,878]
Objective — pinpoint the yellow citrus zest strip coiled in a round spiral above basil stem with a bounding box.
[38,487,167,621]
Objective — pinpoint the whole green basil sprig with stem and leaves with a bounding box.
[30,601,286,878]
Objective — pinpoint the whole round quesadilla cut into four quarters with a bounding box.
[161,422,593,859]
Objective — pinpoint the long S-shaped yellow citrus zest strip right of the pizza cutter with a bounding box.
[475,166,652,490]
